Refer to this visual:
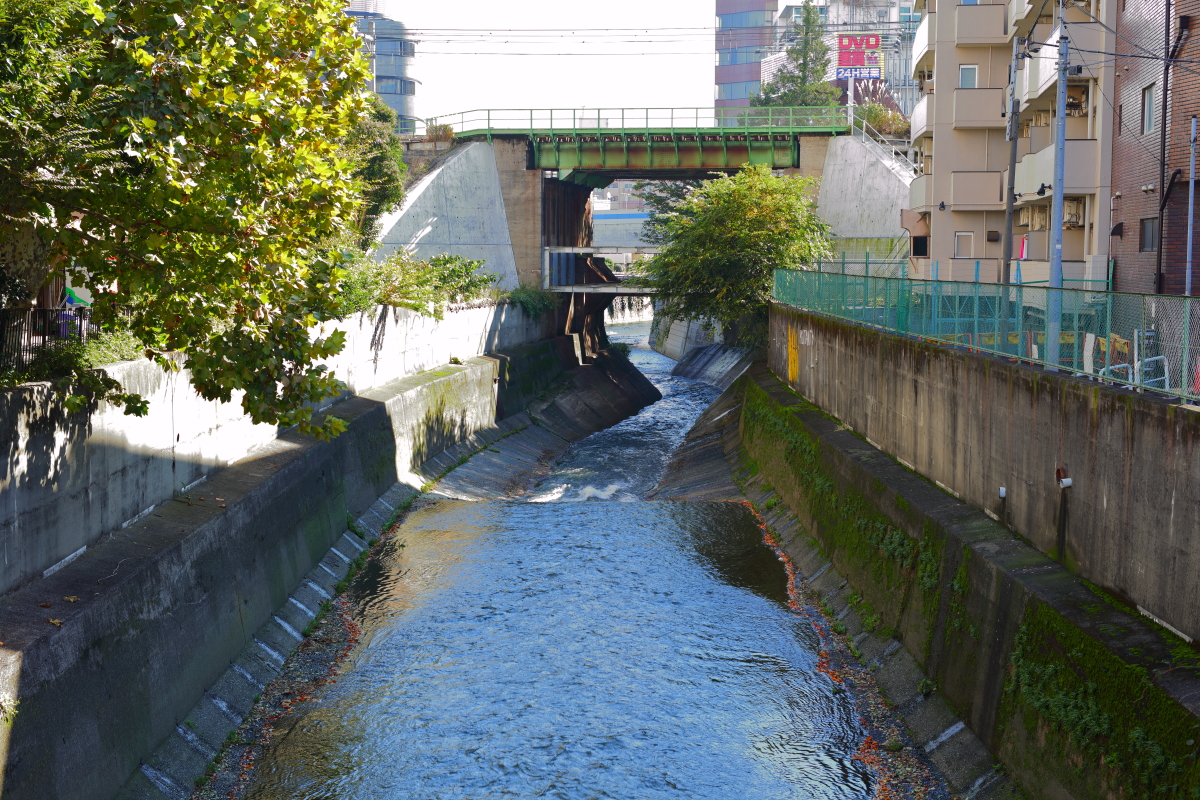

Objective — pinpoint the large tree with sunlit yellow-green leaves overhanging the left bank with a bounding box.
[0,0,366,437]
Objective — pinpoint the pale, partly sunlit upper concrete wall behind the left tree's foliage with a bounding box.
[0,303,551,593]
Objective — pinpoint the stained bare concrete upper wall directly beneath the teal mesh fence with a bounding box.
[769,305,1200,638]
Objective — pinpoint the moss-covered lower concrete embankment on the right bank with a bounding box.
[658,363,1200,800]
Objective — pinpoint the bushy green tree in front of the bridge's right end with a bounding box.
[636,164,829,345]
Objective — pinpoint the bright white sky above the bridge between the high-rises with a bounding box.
[379,0,715,118]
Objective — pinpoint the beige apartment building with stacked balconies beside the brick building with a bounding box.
[904,0,1116,288]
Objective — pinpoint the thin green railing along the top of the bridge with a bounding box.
[426,107,848,136]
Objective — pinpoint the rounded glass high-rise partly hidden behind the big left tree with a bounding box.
[346,0,420,133]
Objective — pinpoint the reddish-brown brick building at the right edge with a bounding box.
[1104,0,1200,294]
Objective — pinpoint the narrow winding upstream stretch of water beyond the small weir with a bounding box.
[529,323,720,503]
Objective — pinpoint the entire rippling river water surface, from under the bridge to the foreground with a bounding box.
[247,324,872,800]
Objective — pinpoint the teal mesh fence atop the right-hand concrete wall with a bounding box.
[772,270,1200,401]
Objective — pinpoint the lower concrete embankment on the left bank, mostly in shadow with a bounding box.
[0,337,656,800]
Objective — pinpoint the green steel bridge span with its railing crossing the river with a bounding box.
[426,107,852,188]
